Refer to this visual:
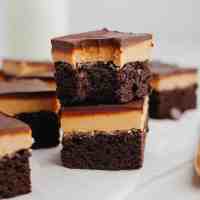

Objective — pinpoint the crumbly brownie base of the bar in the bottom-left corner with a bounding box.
[0,150,31,198]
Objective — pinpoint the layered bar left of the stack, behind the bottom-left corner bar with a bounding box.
[0,79,60,148]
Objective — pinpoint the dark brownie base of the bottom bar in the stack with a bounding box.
[61,130,145,170]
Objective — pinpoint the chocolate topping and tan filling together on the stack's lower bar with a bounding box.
[61,97,148,134]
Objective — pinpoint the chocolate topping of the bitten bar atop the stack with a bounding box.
[51,29,152,50]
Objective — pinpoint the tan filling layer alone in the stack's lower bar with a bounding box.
[61,98,148,134]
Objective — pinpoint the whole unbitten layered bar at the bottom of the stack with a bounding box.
[61,97,148,170]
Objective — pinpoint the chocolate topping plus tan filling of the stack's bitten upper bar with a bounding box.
[51,29,153,67]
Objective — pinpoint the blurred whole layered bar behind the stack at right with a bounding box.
[149,61,198,119]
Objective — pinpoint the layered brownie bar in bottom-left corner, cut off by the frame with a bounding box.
[0,113,32,198]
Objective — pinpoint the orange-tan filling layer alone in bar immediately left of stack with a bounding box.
[0,96,60,116]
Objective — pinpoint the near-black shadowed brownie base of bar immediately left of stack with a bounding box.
[16,111,60,149]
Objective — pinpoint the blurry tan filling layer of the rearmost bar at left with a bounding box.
[2,59,54,78]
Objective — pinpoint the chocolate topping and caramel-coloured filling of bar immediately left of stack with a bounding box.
[0,80,59,115]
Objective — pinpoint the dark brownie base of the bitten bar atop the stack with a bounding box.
[55,62,151,106]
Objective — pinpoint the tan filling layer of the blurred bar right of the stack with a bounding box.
[151,73,198,91]
